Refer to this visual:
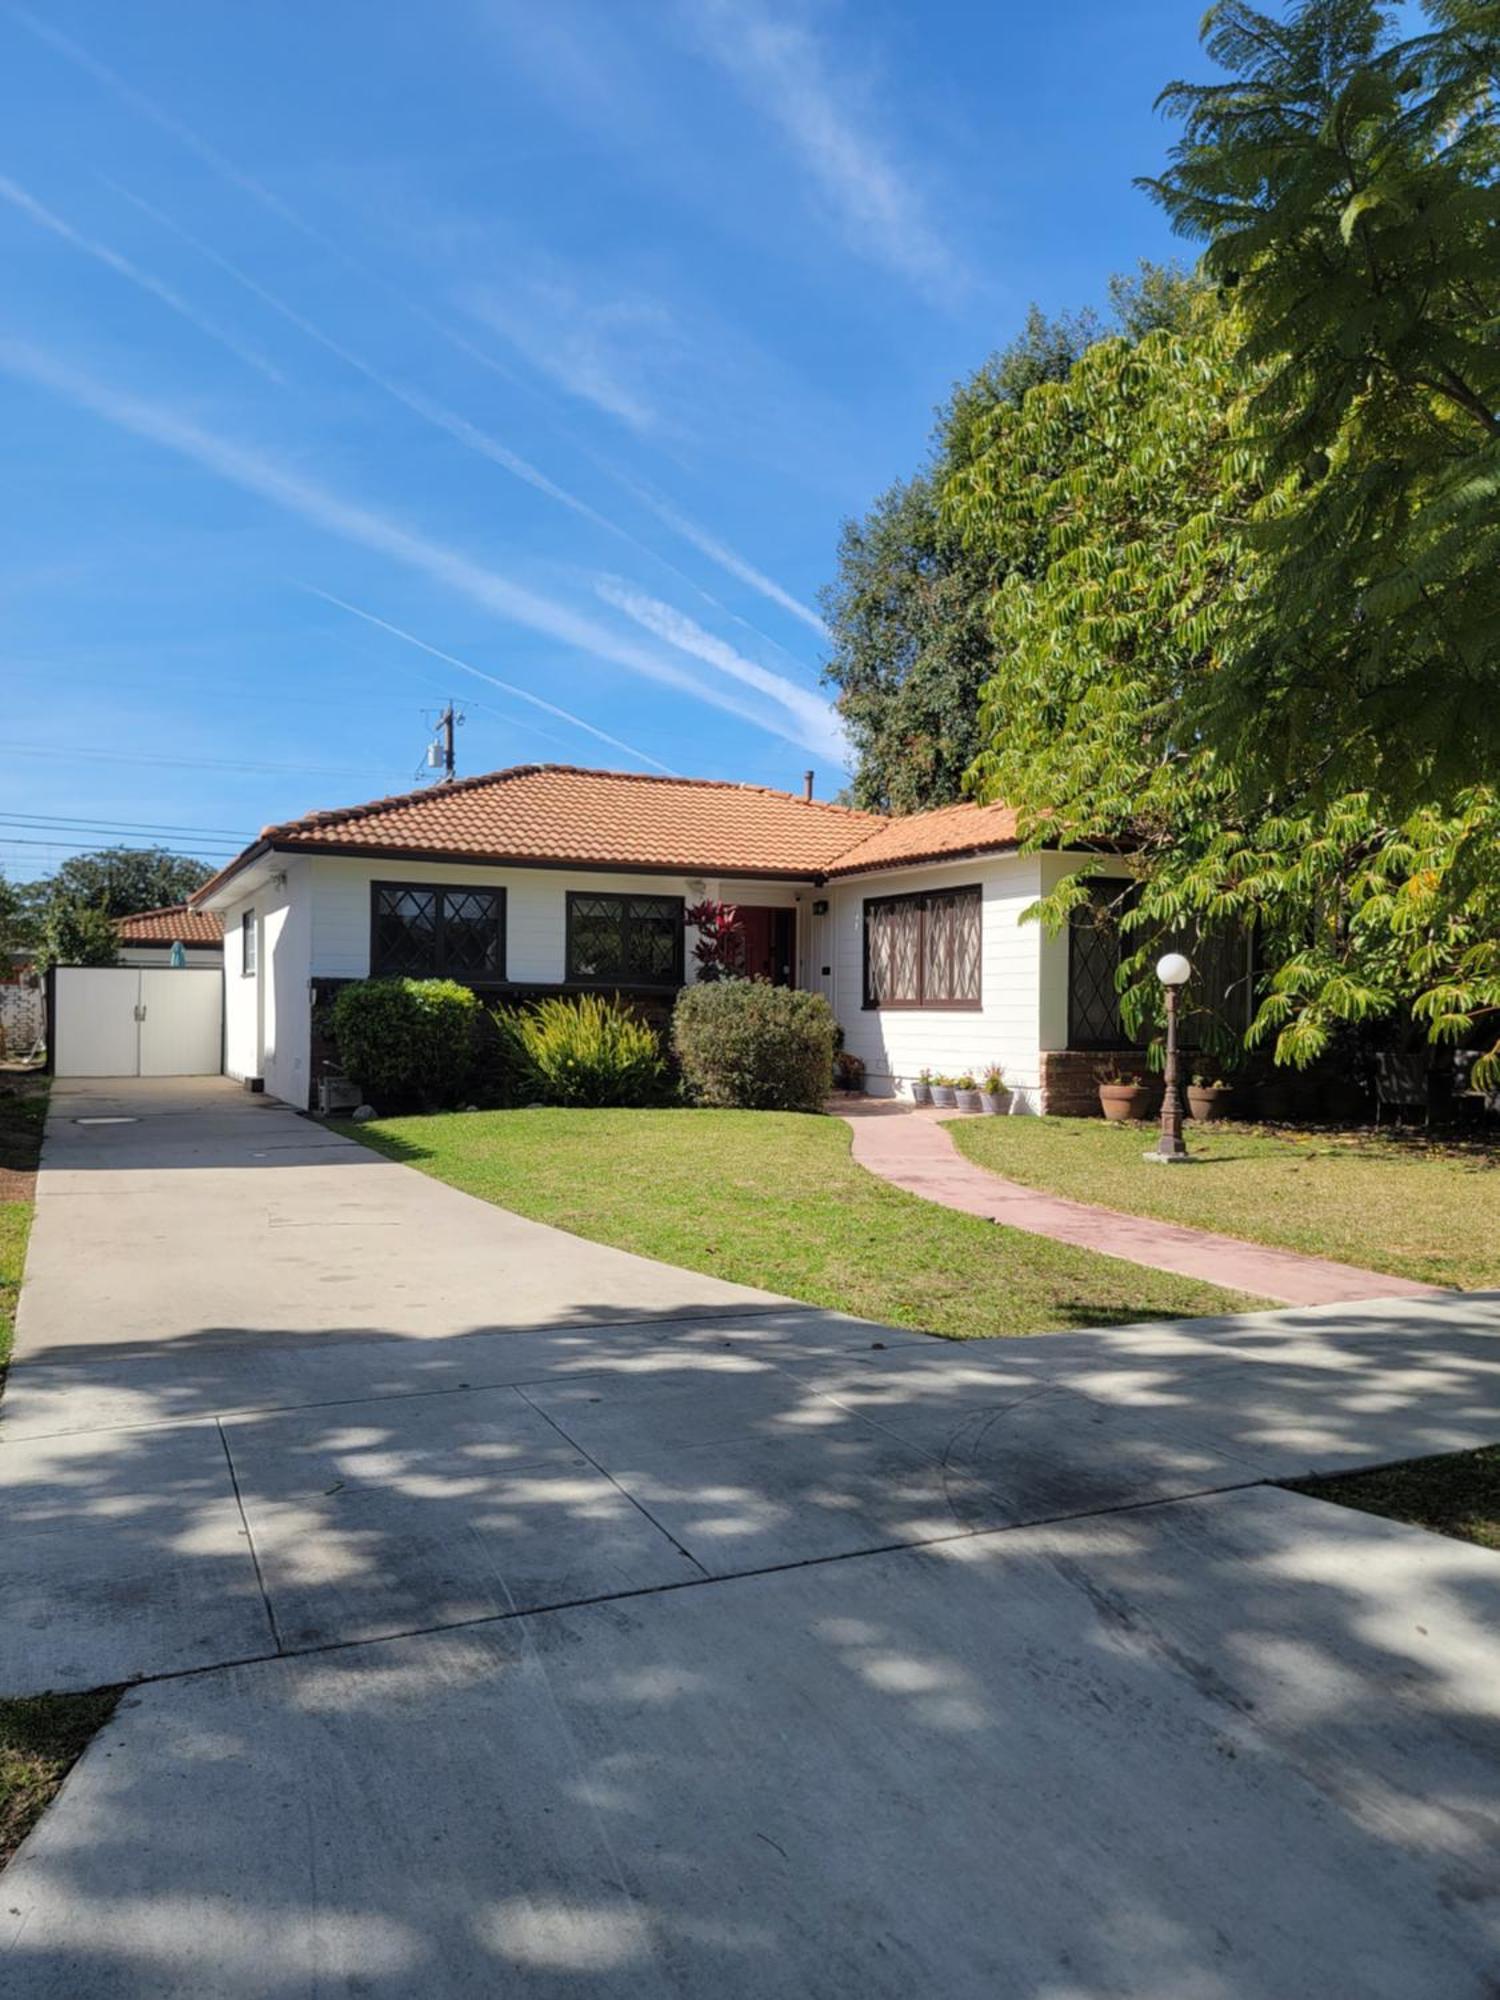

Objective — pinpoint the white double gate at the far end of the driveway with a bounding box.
[52,966,224,1076]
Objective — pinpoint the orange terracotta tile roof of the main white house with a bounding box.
[192,764,1016,904]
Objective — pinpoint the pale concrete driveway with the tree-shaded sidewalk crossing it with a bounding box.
[0,1086,1500,2000]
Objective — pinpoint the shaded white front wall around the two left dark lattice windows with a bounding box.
[308,854,810,988]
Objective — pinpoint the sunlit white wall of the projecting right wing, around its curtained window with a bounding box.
[824,854,1066,1112]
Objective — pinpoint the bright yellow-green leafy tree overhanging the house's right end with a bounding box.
[944,296,1500,1074]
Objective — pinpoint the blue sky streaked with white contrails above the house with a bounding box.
[0,0,1202,878]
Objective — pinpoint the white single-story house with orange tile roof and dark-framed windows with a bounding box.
[192,764,1160,1112]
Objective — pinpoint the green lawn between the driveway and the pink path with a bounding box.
[342,1110,1264,1338]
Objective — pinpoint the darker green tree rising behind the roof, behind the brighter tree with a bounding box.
[824,264,1194,812]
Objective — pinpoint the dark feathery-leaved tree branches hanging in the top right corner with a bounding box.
[1146,0,1500,814]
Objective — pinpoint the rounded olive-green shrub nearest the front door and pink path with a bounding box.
[672,980,836,1112]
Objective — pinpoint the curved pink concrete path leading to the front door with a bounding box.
[832,1098,1444,1306]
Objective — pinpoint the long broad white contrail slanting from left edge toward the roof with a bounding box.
[0,340,824,742]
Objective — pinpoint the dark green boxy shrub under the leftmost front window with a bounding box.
[332,980,480,1110]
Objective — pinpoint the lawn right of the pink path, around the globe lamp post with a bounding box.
[948,1118,1500,1290]
